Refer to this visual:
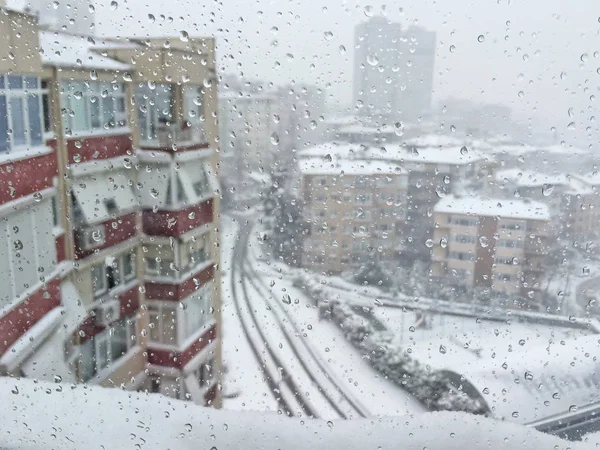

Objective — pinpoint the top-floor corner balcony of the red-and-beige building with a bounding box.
[140,122,208,153]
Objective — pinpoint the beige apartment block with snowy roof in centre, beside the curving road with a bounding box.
[299,158,408,273]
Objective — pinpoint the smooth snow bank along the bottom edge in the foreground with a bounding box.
[0,378,597,450]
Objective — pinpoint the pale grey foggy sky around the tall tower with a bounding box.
[96,0,600,146]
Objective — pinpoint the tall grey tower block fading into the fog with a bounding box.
[353,17,436,122]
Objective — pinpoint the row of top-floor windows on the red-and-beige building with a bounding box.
[0,75,203,152]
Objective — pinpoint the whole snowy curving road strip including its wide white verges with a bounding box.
[224,216,422,420]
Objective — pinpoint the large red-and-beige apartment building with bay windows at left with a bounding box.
[0,6,221,406]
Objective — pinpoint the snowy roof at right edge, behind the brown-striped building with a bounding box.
[496,168,600,195]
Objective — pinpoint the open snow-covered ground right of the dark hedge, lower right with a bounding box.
[374,308,600,423]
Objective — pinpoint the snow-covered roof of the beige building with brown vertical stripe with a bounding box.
[433,195,550,220]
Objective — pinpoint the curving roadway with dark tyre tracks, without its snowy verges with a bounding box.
[231,216,370,419]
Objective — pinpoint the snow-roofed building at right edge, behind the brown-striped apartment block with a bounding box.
[492,168,600,239]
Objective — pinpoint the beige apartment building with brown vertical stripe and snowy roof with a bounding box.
[431,195,550,304]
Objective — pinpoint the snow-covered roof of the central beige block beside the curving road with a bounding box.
[298,158,406,175]
